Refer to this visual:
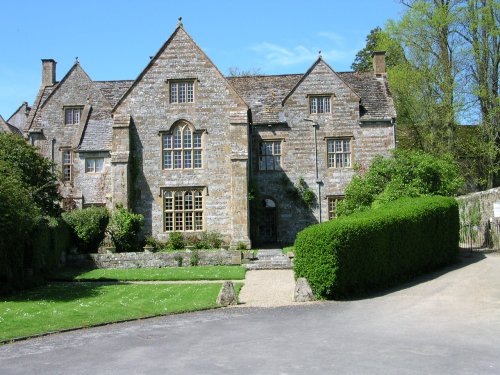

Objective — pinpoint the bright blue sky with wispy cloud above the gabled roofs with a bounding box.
[0,0,403,119]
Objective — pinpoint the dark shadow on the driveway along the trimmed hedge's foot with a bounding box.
[335,252,486,301]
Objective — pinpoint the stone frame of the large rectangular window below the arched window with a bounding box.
[161,186,208,233]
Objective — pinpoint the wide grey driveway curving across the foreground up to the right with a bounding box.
[0,254,500,374]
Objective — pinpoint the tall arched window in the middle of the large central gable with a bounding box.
[162,123,203,169]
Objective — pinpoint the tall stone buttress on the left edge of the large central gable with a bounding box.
[111,116,131,208]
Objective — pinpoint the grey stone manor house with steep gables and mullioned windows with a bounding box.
[0,23,396,246]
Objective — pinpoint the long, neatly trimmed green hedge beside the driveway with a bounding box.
[294,196,459,298]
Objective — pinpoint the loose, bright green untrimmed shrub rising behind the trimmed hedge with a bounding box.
[337,150,463,216]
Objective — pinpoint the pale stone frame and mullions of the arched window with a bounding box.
[159,120,205,170]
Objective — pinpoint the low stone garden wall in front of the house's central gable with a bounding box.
[66,250,241,268]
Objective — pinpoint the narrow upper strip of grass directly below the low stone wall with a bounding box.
[50,266,246,281]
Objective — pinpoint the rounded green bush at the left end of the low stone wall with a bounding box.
[62,207,109,253]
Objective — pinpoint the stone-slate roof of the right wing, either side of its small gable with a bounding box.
[227,72,396,124]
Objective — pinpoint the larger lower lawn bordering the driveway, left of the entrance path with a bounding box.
[0,283,242,341]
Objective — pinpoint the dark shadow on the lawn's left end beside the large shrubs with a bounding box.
[0,283,104,302]
